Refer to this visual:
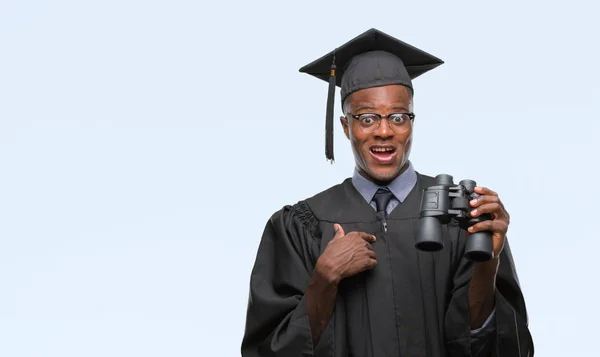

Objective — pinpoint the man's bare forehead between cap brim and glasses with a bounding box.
[348,85,412,108]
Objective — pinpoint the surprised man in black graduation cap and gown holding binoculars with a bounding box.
[242,29,533,357]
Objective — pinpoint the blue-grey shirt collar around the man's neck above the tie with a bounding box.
[352,161,417,203]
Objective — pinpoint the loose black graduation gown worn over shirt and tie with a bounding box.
[242,173,533,357]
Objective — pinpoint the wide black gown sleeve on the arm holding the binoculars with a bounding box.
[445,230,534,357]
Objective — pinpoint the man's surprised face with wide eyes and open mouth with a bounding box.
[340,85,413,184]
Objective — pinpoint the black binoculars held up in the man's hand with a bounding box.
[415,174,493,262]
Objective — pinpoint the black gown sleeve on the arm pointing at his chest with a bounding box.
[241,205,334,357]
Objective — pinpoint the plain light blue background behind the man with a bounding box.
[0,0,600,357]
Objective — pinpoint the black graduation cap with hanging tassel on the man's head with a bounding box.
[300,29,444,161]
